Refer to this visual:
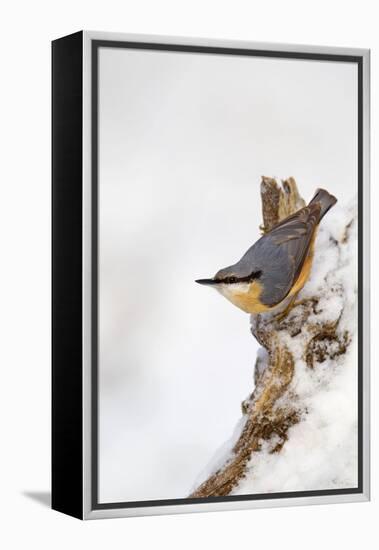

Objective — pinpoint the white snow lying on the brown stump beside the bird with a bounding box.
[193,200,358,495]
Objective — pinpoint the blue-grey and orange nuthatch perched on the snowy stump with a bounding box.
[195,189,337,319]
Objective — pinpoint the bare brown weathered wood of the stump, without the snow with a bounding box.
[190,177,353,497]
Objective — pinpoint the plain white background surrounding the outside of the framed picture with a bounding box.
[0,0,379,549]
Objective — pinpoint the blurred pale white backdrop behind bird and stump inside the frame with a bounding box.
[99,48,358,502]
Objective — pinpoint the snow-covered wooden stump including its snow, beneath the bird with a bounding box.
[190,177,357,497]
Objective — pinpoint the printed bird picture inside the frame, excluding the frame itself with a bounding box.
[95,46,361,504]
